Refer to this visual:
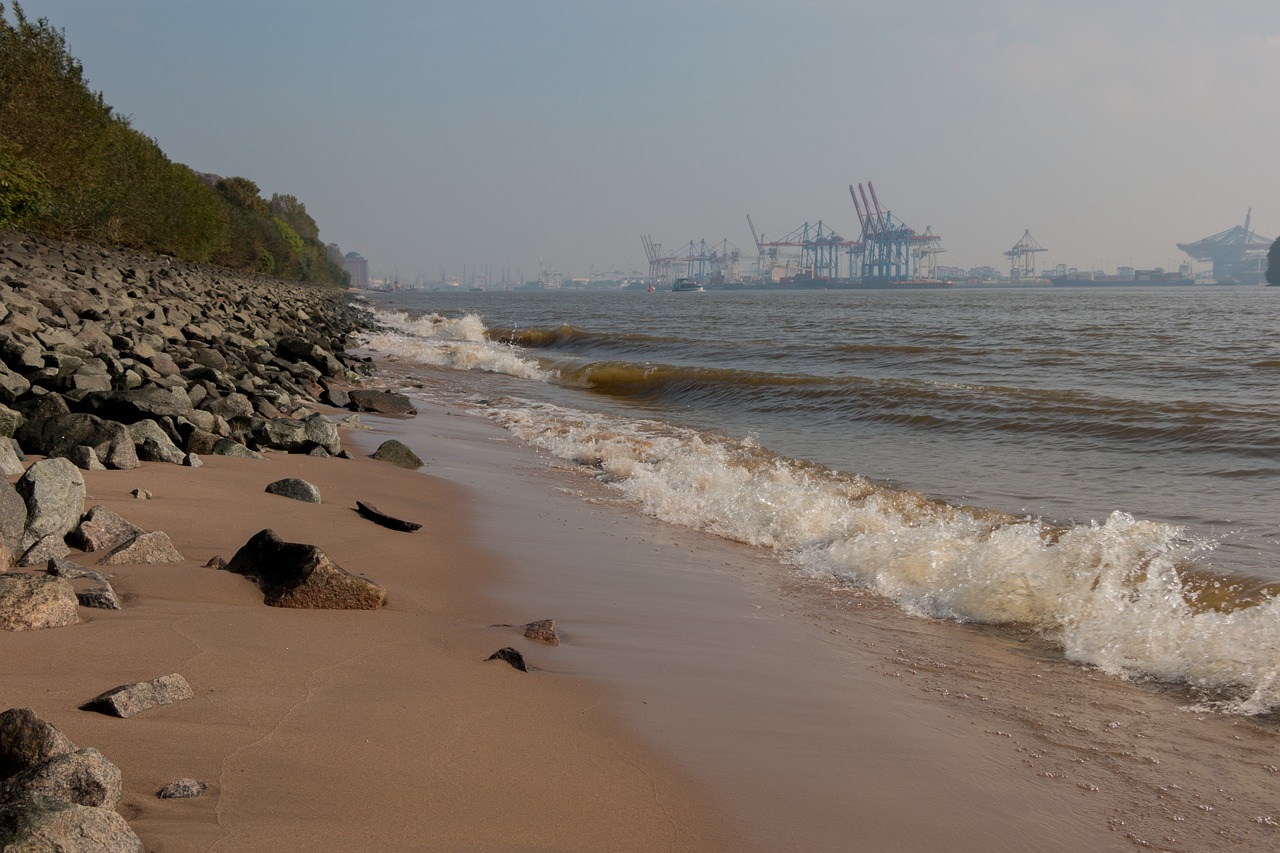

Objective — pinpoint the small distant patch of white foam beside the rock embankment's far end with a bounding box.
[361,310,550,382]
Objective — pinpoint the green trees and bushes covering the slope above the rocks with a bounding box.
[0,3,349,284]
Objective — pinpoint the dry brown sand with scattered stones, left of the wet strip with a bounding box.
[0,435,735,852]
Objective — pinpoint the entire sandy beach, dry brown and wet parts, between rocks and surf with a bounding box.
[4,376,1274,852]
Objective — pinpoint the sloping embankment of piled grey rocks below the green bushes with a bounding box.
[0,233,371,489]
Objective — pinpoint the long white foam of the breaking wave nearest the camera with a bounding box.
[486,401,1280,713]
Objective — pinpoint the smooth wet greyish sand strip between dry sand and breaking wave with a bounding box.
[357,389,1280,852]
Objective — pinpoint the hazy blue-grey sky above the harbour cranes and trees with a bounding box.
[17,0,1280,280]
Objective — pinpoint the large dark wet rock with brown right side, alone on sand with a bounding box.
[227,530,387,610]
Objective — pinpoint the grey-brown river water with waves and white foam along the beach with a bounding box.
[355,287,1280,713]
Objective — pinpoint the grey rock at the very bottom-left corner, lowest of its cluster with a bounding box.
[0,798,142,853]
